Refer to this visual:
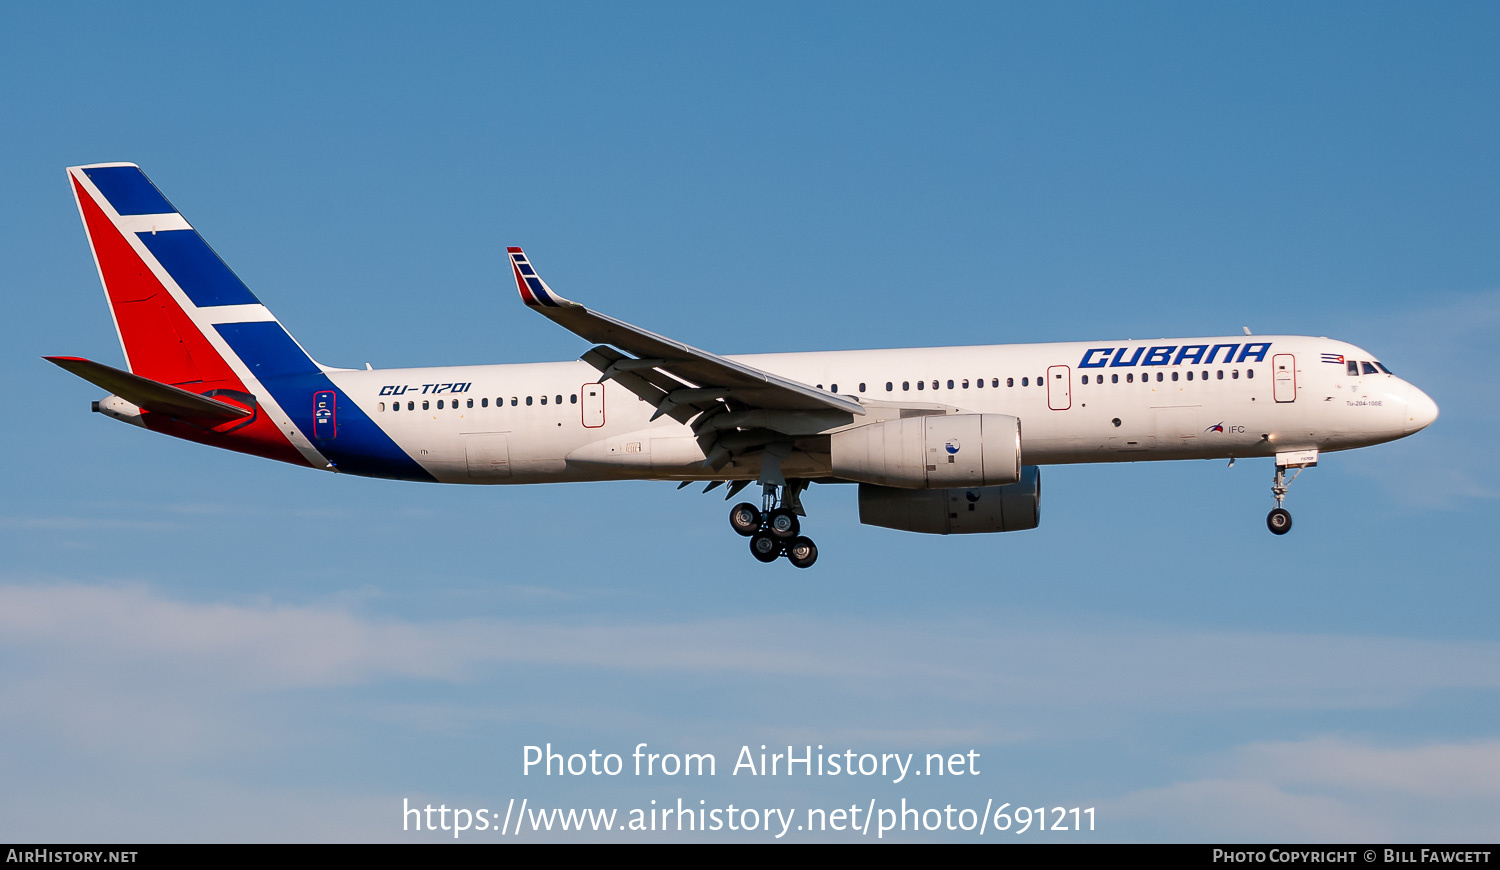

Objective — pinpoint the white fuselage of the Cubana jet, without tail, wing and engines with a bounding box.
[313,336,1437,483]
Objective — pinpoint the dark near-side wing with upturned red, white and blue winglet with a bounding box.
[507,248,866,423]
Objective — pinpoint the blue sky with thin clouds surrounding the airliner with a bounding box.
[0,3,1500,842]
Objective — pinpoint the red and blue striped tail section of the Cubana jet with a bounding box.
[53,164,432,480]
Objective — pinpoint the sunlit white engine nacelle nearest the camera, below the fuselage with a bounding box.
[830,414,1022,489]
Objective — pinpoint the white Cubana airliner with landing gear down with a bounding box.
[44,164,1439,569]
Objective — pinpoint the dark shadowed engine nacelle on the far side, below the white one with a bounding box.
[860,465,1041,534]
